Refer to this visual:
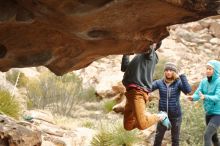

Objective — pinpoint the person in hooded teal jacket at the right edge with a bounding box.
[188,60,220,146]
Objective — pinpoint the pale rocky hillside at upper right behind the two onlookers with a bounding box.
[160,16,220,84]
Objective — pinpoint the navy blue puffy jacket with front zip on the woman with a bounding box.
[152,75,191,118]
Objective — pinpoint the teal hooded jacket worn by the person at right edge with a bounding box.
[193,60,220,115]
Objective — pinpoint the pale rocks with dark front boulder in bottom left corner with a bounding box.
[0,110,96,146]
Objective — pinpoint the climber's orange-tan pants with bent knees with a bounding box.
[124,89,159,130]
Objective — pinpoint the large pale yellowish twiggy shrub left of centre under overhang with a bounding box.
[27,72,95,115]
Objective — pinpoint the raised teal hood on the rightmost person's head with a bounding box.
[207,60,220,81]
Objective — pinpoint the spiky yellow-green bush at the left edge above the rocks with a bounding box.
[0,90,21,119]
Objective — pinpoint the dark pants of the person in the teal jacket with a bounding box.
[204,115,220,146]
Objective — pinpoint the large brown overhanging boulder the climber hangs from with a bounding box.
[0,0,219,75]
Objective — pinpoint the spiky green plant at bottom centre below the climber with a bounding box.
[91,121,143,146]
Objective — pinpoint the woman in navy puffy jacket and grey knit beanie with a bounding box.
[152,62,191,146]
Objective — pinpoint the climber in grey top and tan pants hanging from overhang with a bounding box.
[121,42,171,130]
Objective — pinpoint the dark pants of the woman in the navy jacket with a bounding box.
[154,117,182,146]
